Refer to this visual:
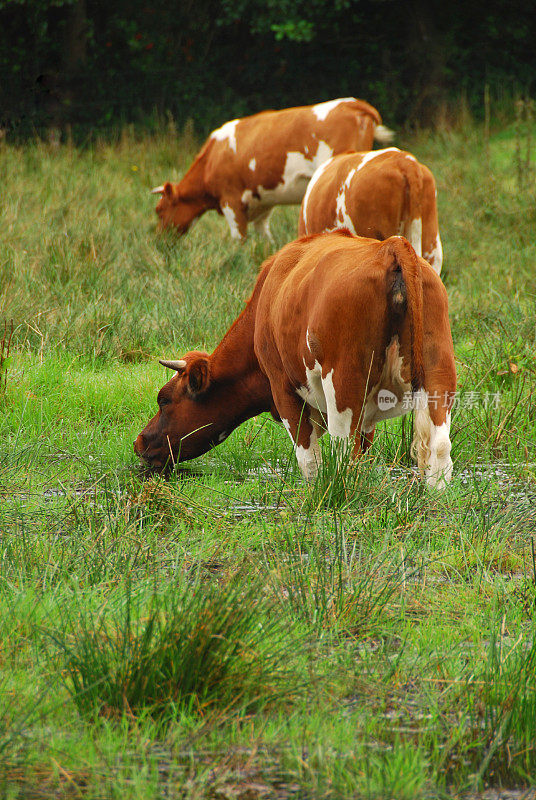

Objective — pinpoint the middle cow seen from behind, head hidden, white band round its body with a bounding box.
[298,147,443,275]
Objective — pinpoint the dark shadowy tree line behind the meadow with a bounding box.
[0,0,536,135]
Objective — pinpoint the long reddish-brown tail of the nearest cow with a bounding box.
[385,236,424,392]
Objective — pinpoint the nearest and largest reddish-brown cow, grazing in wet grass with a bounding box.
[134,230,456,488]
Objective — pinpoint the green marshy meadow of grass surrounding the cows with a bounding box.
[0,114,536,800]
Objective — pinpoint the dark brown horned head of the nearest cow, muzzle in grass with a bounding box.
[134,351,234,472]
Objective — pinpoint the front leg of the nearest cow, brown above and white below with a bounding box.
[272,386,321,481]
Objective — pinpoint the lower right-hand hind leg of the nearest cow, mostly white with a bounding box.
[411,387,453,489]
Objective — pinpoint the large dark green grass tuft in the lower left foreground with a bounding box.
[53,574,299,722]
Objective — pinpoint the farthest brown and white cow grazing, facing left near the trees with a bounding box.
[152,97,392,239]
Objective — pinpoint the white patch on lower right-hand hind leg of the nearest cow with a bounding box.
[411,389,452,490]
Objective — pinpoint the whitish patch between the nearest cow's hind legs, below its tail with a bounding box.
[361,337,412,433]
